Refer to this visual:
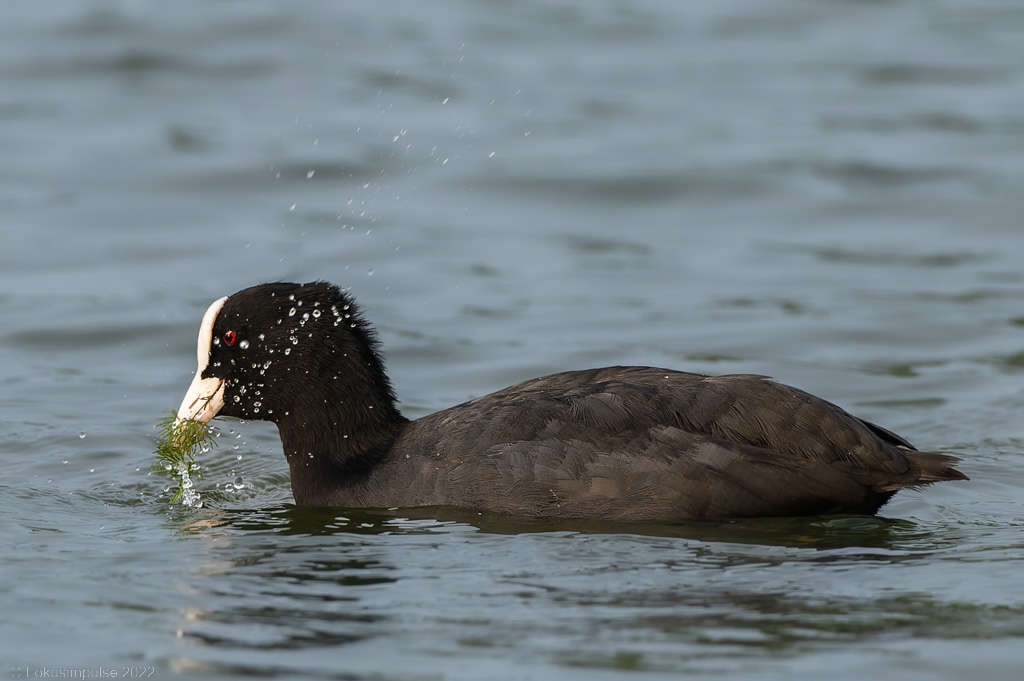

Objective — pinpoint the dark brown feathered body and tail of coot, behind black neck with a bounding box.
[387,368,963,519]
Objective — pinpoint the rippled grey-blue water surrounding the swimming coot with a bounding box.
[0,0,1024,680]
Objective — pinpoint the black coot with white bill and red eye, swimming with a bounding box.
[179,282,967,520]
